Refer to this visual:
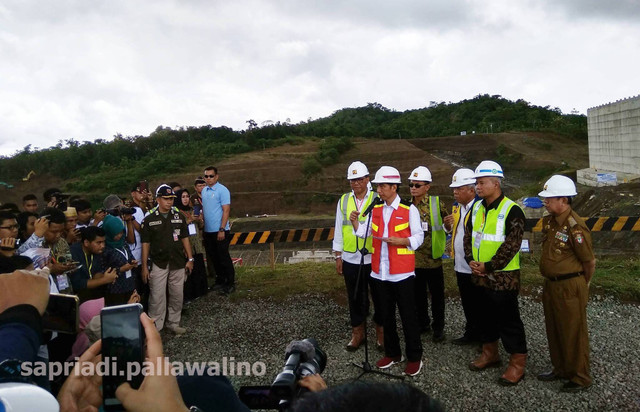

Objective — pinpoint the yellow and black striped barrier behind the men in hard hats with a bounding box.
[231,216,640,245]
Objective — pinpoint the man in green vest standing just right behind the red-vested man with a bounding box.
[409,166,451,342]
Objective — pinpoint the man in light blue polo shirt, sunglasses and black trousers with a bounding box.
[200,166,236,295]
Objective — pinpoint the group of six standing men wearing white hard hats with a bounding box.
[333,160,595,392]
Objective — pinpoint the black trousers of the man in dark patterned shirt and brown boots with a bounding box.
[480,288,527,353]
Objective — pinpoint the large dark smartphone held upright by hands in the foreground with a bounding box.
[100,303,145,411]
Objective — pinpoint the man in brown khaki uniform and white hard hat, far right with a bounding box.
[538,175,596,392]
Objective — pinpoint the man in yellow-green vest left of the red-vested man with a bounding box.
[333,161,384,351]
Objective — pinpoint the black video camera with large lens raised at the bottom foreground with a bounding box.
[238,338,327,411]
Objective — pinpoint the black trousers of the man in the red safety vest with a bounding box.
[371,276,422,362]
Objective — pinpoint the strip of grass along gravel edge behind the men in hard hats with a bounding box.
[232,255,640,303]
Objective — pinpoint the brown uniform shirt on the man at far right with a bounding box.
[540,208,595,277]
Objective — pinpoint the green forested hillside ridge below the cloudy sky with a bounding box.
[0,95,587,192]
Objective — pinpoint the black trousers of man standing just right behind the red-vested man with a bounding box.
[415,266,444,332]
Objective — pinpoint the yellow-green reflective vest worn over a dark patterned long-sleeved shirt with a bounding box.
[471,197,520,272]
